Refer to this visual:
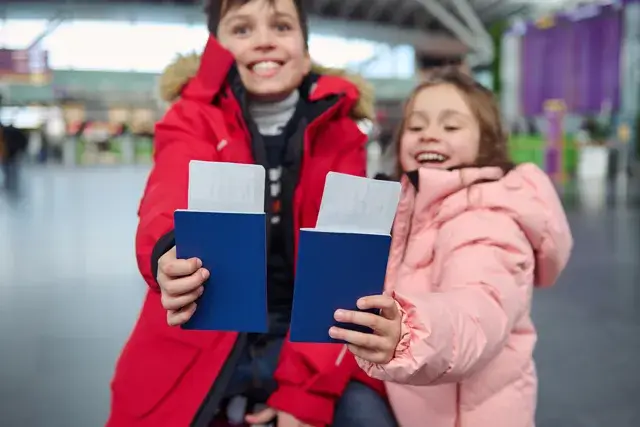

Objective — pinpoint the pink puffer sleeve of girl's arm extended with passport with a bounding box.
[358,210,534,386]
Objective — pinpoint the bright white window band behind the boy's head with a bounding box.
[0,20,415,78]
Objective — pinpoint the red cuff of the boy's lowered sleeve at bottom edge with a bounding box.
[267,385,336,427]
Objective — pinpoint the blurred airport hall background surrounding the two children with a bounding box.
[0,0,640,427]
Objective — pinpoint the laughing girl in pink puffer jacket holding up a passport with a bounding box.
[329,70,572,427]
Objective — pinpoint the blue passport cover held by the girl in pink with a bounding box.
[289,230,391,343]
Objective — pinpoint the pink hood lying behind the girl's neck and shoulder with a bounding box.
[403,164,573,287]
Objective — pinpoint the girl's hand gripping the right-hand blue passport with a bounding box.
[329,295,402,364]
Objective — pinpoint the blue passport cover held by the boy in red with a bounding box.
[174,210,268,333]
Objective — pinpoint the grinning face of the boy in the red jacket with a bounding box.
[217,0,311,102]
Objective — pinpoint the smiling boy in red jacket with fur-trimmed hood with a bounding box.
[108,0,396,427]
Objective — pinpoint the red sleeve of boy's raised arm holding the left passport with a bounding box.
[136,100,216,290]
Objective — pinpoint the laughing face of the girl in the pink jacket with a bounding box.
[399,84,480,171]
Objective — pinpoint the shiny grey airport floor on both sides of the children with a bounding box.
[0,168,640,427]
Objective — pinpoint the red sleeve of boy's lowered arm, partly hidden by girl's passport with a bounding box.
[268,122,367,426]
